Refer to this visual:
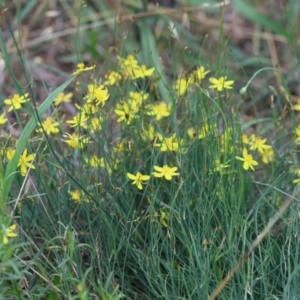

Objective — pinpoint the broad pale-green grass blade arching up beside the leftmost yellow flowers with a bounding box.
[0,77,73,209]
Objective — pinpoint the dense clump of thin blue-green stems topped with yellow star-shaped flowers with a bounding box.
[0,1,300,299]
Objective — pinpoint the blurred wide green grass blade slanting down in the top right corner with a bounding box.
[232,0,291,40]
